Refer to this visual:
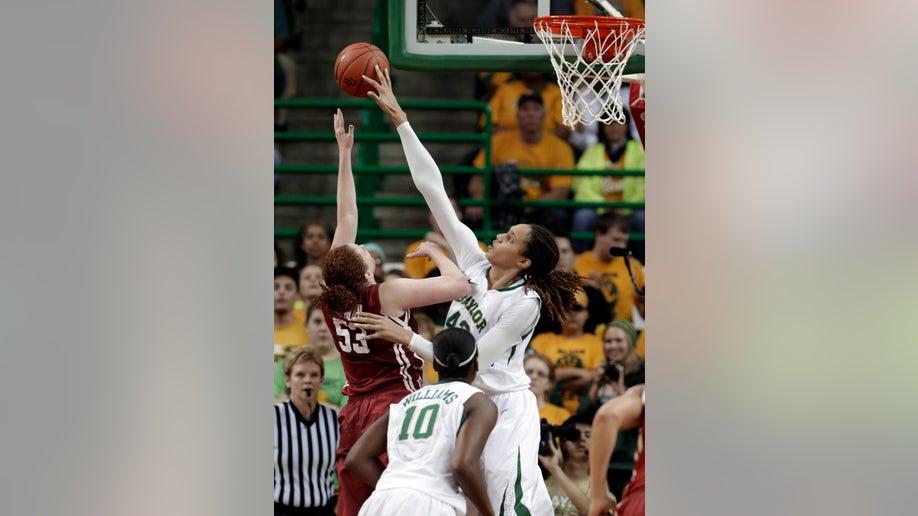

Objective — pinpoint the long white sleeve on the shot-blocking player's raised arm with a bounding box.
[397,122,483,270]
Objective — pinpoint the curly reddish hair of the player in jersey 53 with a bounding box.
[317,245,367,314]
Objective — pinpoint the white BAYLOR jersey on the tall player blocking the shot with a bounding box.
[445,251,542,396]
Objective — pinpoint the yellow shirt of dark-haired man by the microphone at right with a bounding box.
[574,251,644,321]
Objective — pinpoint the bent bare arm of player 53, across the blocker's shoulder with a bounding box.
[379,242,471,316]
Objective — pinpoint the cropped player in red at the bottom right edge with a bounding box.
[589,384,647,516]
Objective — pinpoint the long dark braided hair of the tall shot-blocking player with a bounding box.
[522,224,581,320]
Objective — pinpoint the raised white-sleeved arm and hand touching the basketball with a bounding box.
[363,67,482,267]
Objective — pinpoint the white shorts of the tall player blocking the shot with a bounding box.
[482,390,554,516]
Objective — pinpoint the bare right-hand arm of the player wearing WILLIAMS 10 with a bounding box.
[449,393,497,516]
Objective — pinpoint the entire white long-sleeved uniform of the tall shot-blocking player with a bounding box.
[397,122,552,516]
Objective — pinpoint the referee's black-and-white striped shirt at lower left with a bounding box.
[274,401,339,507]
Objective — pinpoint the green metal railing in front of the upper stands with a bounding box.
[274,99,645,246]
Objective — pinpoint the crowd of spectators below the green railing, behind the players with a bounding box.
[274,203,645,514]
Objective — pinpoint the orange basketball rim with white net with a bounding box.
[533,16,644,129]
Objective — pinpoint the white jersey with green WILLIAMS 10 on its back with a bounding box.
[376,381,481,514]
